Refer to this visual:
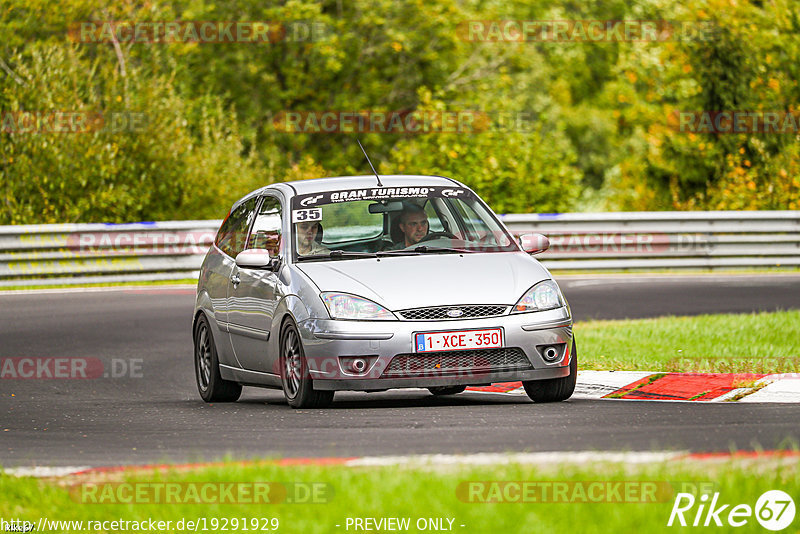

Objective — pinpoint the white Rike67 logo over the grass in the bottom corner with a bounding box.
[667,490,795,531]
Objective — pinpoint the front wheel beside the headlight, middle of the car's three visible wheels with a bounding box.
[280,320,334,408]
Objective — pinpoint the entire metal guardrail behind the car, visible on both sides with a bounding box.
[0,211,800,287]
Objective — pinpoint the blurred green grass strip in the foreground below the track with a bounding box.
[0,456,800,534]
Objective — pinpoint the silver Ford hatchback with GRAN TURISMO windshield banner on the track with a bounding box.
[192,175,578,408]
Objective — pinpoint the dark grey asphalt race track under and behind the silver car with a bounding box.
[0,274,800,466]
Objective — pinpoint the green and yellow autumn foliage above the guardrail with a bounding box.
[0,0,800,224]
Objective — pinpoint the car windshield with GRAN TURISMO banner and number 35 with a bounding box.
[292,186,519,260]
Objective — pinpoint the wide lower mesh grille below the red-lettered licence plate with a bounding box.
[383,347,533,378]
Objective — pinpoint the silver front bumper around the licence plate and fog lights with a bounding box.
[298,306,572,391]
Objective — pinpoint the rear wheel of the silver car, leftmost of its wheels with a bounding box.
[194,313,242,402]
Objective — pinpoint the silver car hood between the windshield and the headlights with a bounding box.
[297,252,550,311]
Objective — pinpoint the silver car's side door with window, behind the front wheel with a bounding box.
[228,195,283,374]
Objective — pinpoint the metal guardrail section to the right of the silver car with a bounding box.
[502,211,800,271]
